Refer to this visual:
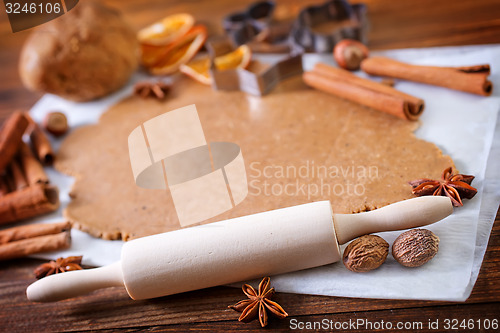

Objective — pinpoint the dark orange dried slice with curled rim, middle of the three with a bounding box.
[148,25,207,75]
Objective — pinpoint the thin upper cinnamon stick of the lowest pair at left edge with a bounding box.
[0,222,71,245]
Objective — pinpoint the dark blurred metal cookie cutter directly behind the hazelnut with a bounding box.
[289,0,368,52]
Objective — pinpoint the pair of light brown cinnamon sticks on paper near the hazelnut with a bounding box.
[303,57,493,120]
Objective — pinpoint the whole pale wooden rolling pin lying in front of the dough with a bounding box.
[26,196,453,302]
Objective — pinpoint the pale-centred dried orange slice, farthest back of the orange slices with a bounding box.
[137,14,194,46]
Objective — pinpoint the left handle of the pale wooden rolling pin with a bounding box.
[26,262,123,302]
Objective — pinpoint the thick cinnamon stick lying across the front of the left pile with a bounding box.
[0,184,59,224]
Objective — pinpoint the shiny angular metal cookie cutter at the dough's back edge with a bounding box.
[207,39,303,96]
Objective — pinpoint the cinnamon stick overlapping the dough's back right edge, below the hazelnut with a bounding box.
[303,63,424,120]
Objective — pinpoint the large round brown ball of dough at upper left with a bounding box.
[19,1,139,102]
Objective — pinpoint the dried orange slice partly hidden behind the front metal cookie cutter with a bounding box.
[179,45,252,85]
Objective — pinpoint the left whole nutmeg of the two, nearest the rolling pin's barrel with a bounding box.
[343,235,389,273]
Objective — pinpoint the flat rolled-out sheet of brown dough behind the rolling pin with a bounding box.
[56,76,453,240]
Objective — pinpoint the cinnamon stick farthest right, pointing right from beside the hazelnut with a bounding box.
[361,57,493,96]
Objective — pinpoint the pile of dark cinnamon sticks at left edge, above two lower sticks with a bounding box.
[0,112,59,224]
